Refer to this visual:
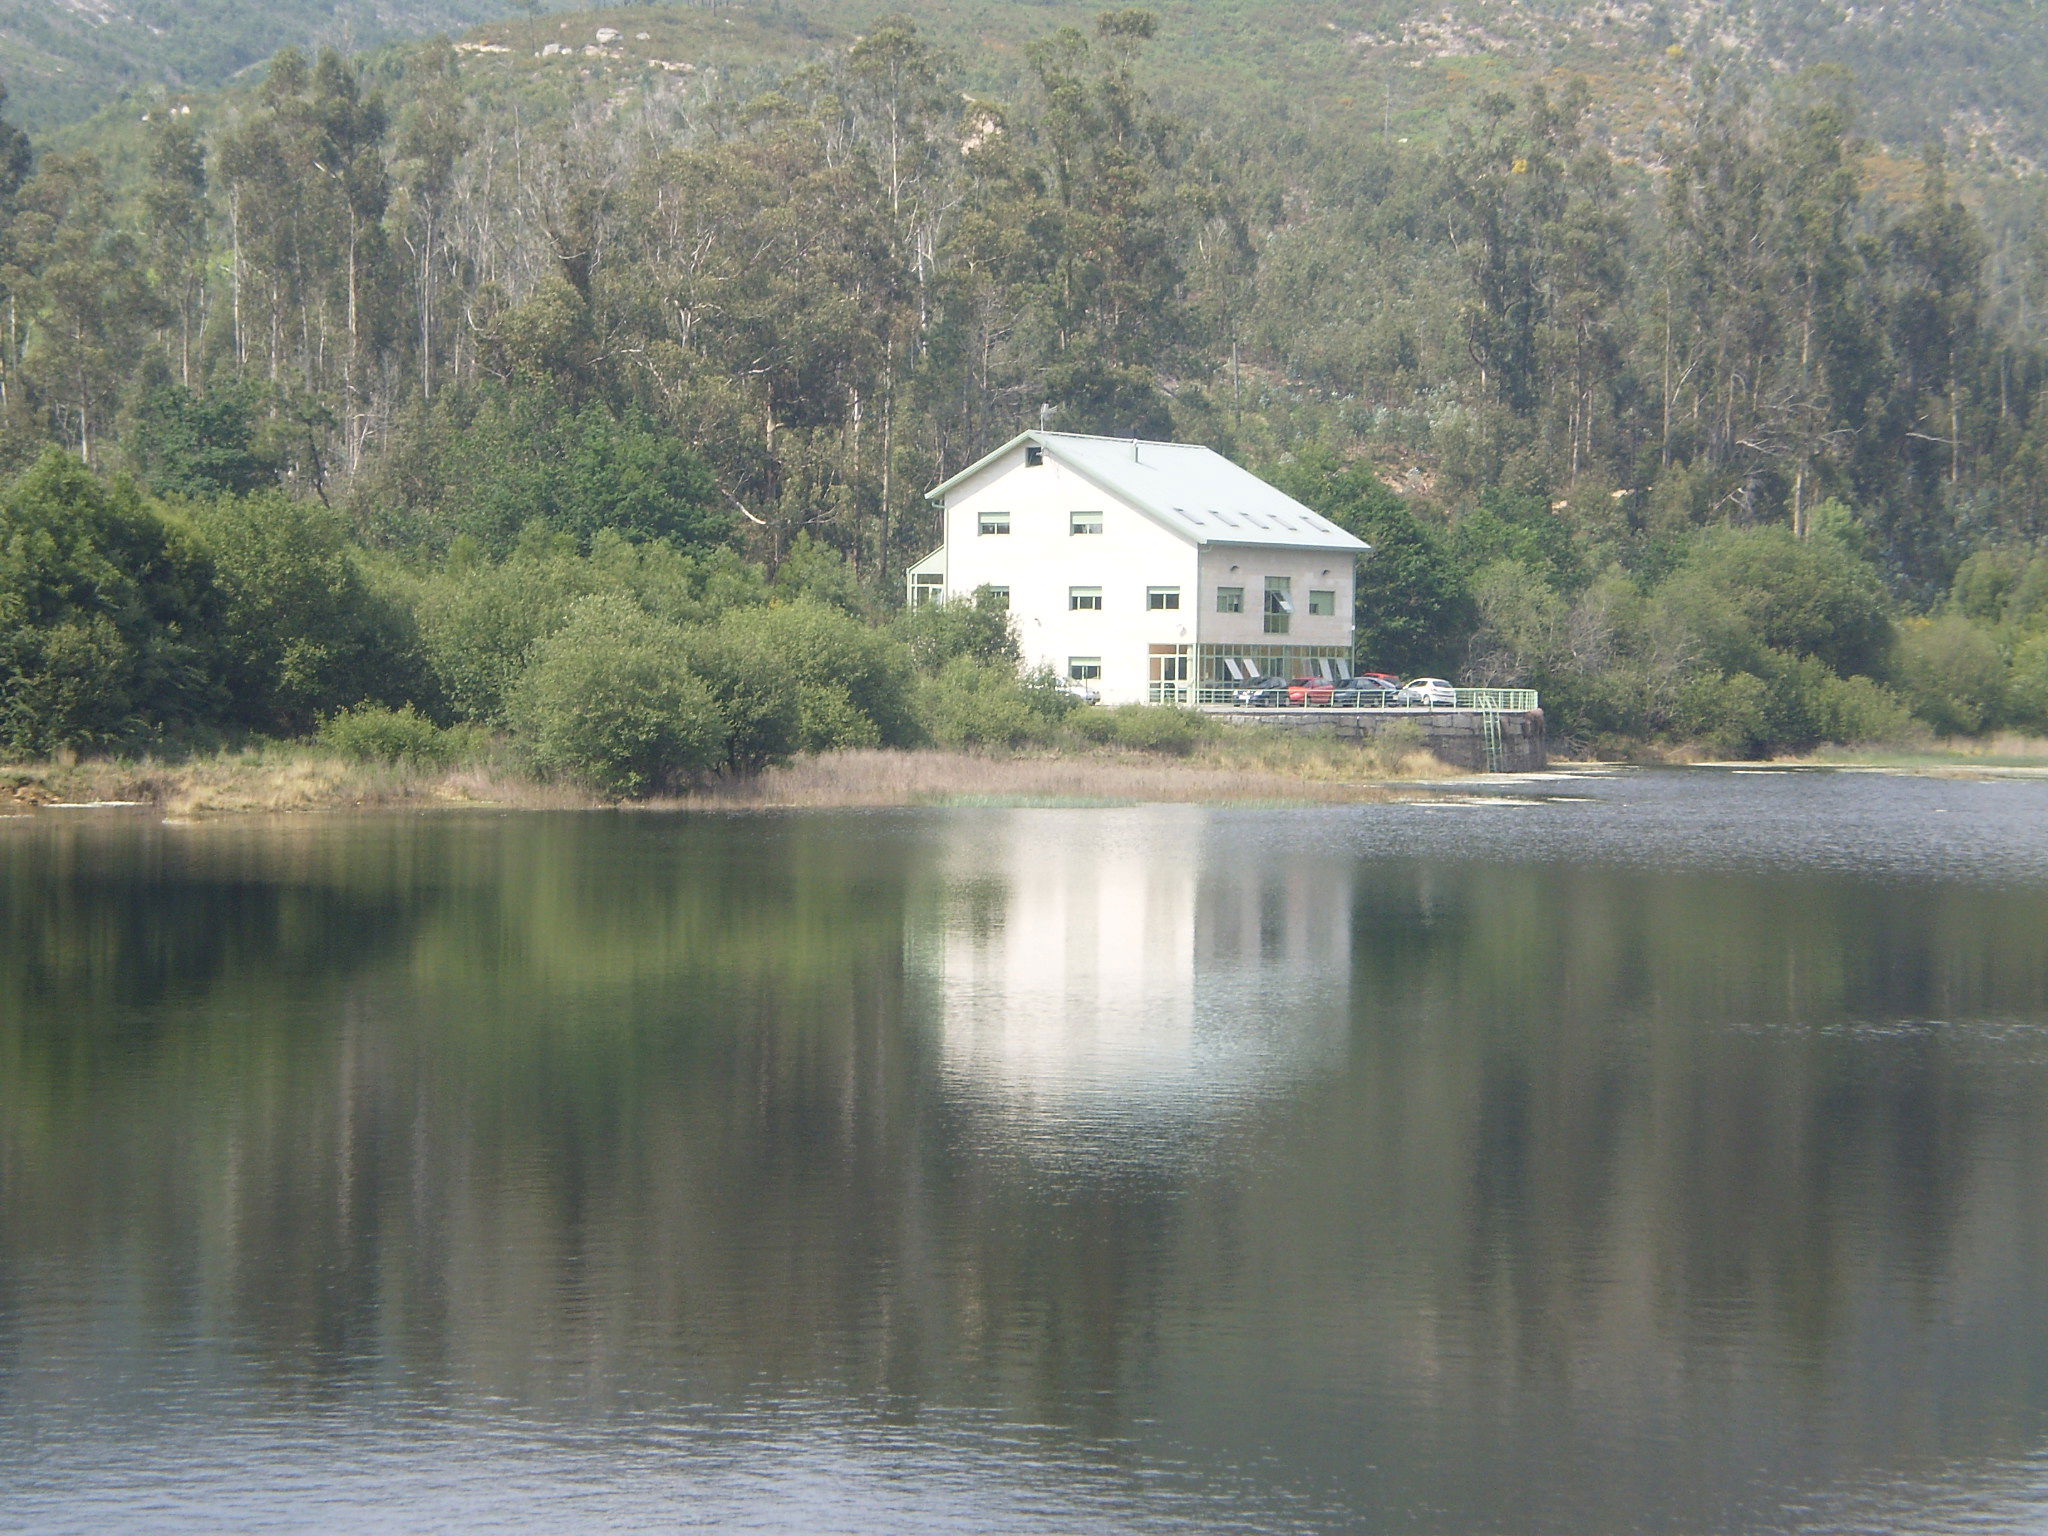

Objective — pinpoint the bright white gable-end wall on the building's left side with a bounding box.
[946,449,1198,705]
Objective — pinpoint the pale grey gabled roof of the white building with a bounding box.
[926,432,1372,553]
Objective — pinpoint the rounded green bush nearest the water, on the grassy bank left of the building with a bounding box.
[506,596,727,799]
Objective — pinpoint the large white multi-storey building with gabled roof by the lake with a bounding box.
[907,432,1372,705]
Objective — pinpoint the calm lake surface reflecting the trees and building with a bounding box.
[0,770,2048,1536]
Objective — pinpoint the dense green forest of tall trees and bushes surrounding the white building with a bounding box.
[0,10,2048,788]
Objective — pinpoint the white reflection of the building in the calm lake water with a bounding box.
[915,807,1354,1112]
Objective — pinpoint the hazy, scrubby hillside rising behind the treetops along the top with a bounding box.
[32,0,2048,170]
